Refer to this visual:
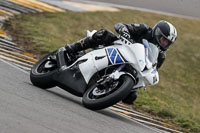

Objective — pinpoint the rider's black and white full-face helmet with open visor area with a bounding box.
[152,20,177,51]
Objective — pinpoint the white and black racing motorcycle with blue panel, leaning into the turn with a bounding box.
[30,31,159,110]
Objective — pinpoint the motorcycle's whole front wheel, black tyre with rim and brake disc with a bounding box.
[82,75,134,110]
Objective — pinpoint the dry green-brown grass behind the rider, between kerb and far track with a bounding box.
[5,10,200,132]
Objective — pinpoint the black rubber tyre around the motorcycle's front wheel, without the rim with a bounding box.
[82,75,134,110]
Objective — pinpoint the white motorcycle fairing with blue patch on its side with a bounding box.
[77,35,159,88]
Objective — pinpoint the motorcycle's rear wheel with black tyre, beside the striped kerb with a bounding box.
[30,51,57,89]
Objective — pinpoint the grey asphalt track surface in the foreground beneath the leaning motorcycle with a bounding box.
[0,60,161,133]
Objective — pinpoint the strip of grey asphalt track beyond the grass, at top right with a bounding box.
[72,0,200,18]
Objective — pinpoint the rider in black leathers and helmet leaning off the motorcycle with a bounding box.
[65,20,177,104]
